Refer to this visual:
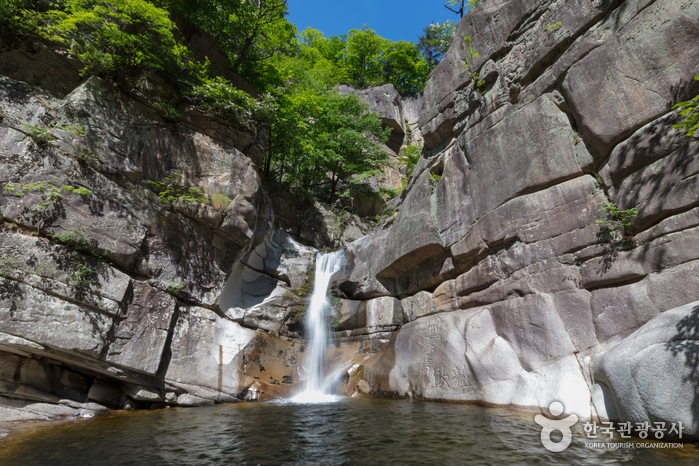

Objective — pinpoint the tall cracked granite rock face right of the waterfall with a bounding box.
[338,0,699,424]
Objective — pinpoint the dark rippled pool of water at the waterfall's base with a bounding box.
[0,399,699,466]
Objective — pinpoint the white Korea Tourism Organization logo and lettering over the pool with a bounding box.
[534,401,684,453]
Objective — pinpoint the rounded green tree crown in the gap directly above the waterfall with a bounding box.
[266,86,390,203]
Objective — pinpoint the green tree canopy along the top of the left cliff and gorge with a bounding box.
[0,0,464,206]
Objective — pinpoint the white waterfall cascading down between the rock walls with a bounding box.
[293,251,345,403]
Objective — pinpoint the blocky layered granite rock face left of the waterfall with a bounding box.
[0,44,308,420]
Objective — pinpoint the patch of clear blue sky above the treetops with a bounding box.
[288,0,459,42]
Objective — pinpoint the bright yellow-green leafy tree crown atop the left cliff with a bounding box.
[43,0,186,88]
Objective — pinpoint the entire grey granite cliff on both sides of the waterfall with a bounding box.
[0,0,699,437]
